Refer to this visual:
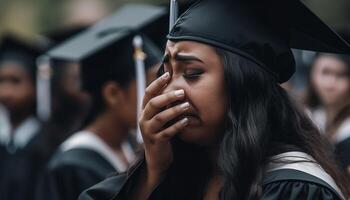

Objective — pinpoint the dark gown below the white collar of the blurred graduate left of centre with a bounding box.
[36,148,116,200]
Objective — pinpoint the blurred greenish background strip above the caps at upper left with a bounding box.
[0,0,167,36]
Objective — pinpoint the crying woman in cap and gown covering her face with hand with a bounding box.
[80,0,349,200]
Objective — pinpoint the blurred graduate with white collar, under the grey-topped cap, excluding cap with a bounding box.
[33,34,161,200]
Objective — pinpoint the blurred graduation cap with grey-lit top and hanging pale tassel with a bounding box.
[37,4,168,120]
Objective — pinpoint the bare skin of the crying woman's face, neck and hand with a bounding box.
[132,41,227,200]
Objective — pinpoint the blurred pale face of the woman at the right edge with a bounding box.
[311,55,350,105]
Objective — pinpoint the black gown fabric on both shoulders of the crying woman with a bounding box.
[79,170,341,200]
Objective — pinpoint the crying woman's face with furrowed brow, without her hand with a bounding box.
[163,41,227,145]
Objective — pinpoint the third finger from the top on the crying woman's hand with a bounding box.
[149,102,190,132]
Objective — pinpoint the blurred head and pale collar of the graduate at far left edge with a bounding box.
[0,36,40,153]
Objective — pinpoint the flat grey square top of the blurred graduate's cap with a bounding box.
[48,4,167,62]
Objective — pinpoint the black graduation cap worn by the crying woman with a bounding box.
[168,0,350,83]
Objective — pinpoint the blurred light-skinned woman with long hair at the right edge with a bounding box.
[305,53,350,173]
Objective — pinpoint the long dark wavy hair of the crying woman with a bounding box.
[154,49,350,200]
